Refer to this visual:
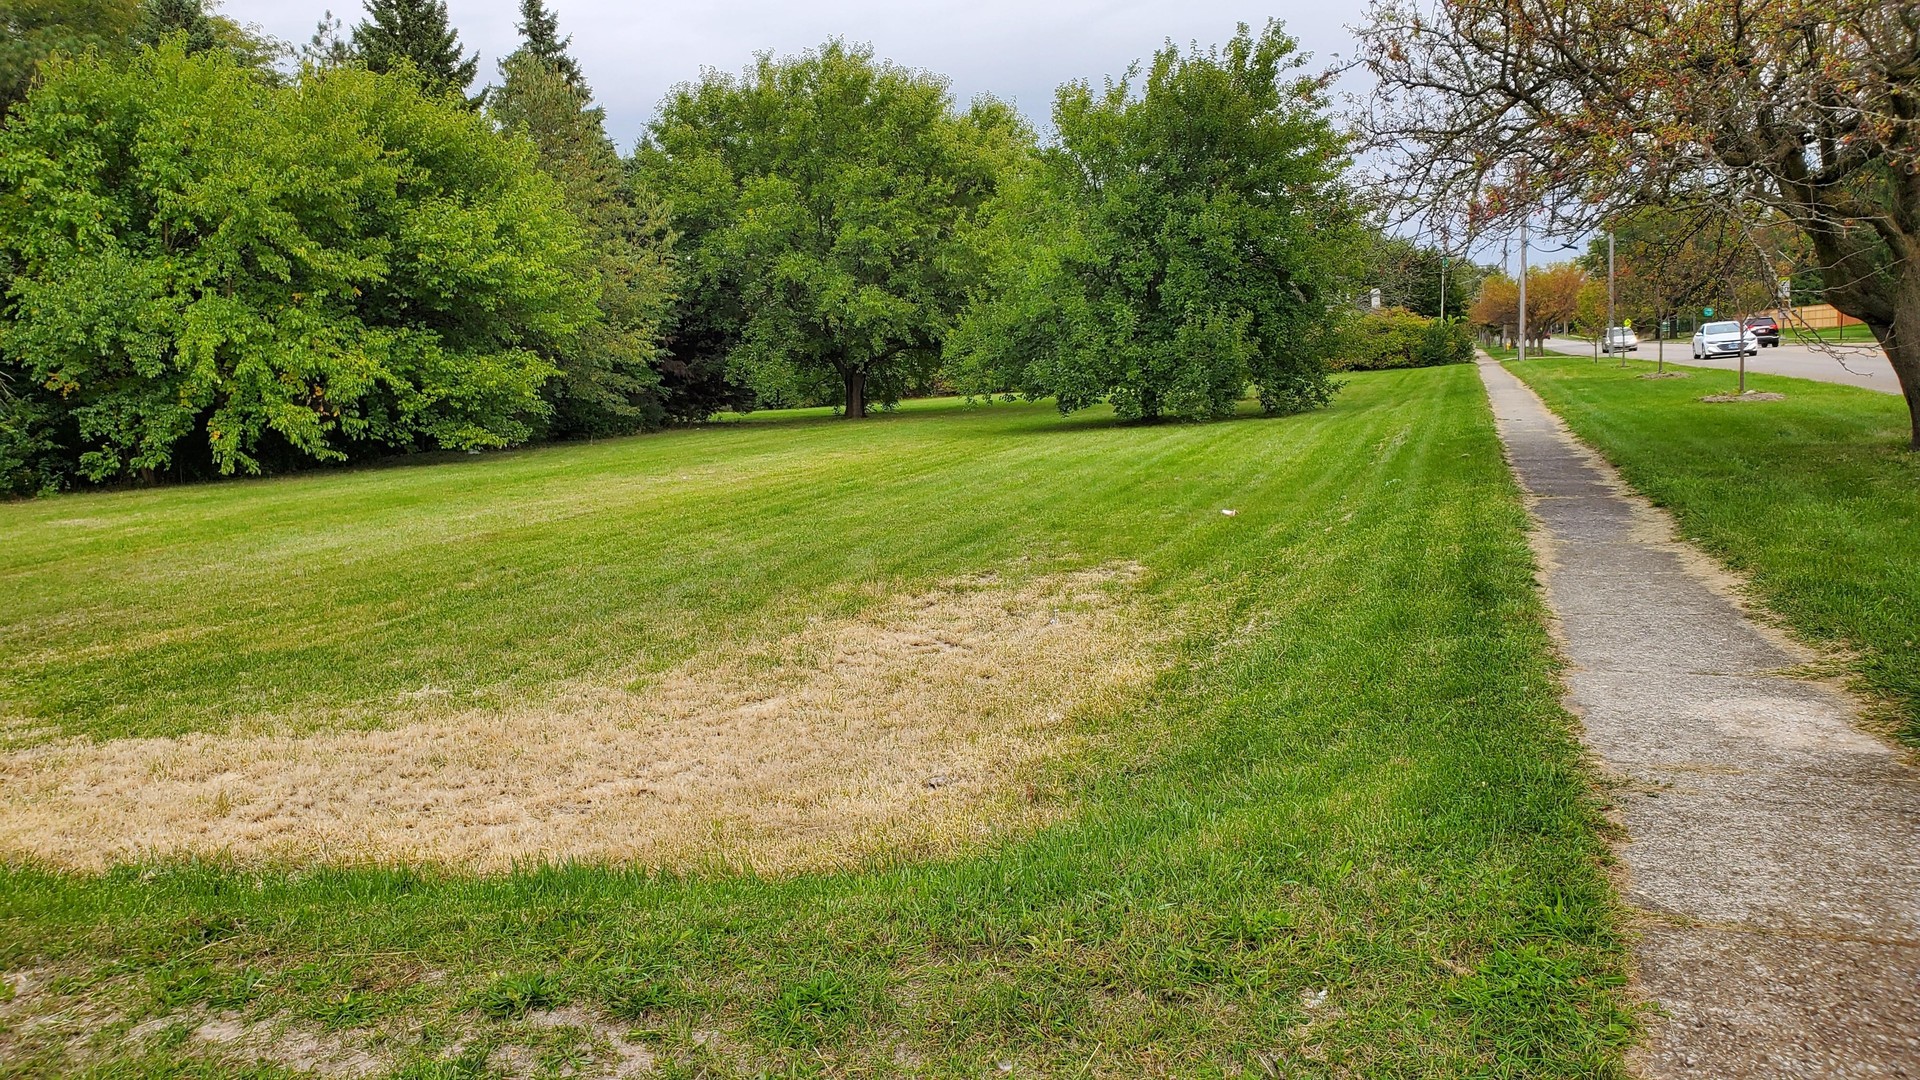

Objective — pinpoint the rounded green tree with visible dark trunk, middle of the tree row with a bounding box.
[639,40,996,417]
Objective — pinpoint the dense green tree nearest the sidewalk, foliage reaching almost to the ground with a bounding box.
[948,25,1361,419]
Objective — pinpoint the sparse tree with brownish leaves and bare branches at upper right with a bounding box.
[1361,0,1920,448]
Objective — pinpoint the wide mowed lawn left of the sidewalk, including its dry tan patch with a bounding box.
[0,367,1634,1076]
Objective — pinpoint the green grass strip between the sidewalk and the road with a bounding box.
[1513,359,1920,738]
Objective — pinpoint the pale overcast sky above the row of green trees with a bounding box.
[221,0,1361,150]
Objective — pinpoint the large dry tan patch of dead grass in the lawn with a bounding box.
[0,565,1154,871]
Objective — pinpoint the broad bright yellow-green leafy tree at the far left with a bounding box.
[0,38,599,488]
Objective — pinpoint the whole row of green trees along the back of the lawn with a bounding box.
[0,0,1363,488]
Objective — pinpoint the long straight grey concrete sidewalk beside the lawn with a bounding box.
[1480,357,1920,1080]
